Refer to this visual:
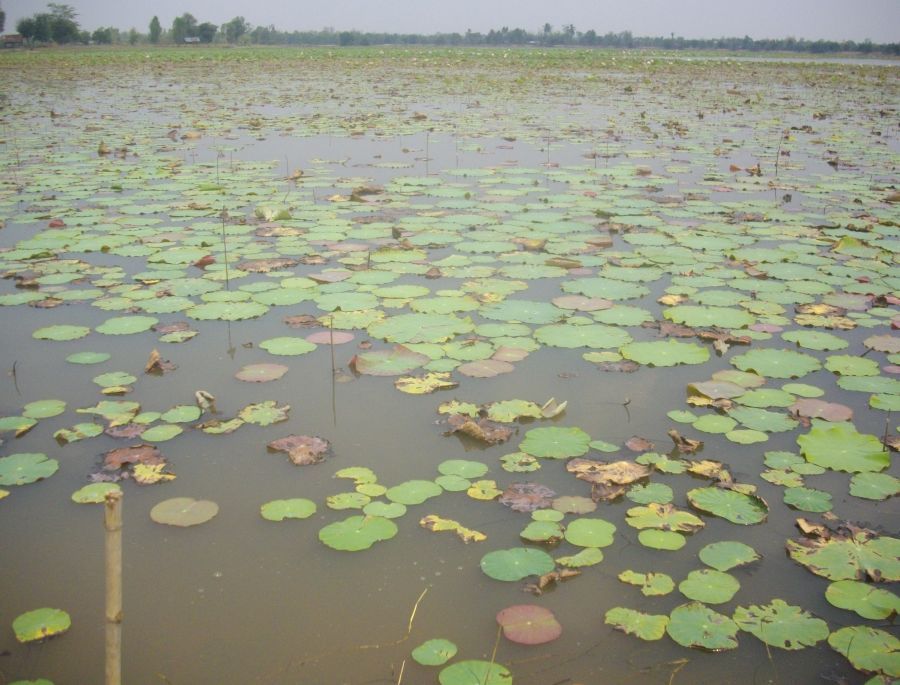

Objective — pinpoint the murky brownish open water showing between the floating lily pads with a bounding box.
[0,48,900,685]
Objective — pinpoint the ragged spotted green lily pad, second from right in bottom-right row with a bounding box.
[734,599,829,650]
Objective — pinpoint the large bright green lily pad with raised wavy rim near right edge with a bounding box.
[797,421,891,473]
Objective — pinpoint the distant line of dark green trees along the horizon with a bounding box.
[8,2,900,55]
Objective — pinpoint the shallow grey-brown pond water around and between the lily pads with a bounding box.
[0,51,900,685]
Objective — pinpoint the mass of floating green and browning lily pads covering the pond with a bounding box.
[0,45,900,685]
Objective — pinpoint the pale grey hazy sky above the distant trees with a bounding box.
[7,0,900,43]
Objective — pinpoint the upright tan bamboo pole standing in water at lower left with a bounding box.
[105,492,122,685]
